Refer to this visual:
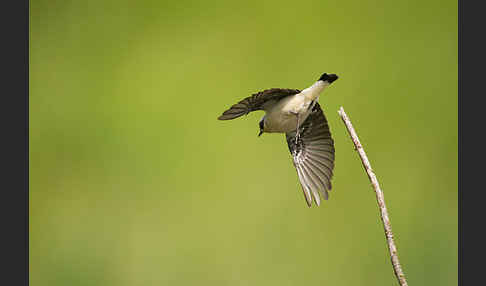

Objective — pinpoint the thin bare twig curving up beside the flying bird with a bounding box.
[338,107,408,286]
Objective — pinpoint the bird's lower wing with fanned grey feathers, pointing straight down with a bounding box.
[285,102,334,207]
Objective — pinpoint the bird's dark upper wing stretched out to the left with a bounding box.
[218,88,300,120]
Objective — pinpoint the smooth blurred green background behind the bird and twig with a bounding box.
[29,0,458,286]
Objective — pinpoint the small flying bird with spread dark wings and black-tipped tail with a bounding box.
[218,73,339,207]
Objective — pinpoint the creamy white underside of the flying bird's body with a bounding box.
[264,81,329,133]
